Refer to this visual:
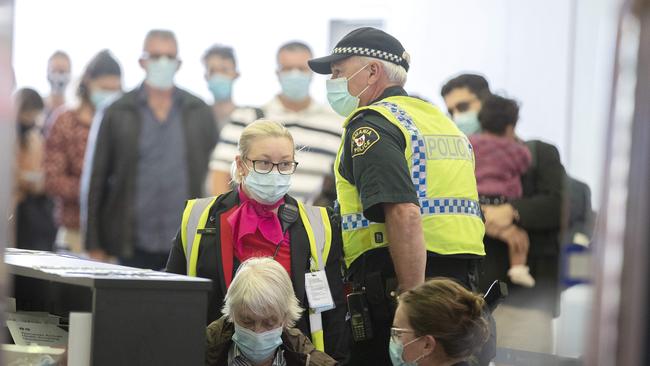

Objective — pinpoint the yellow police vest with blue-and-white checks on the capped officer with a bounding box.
[334,96,485,267]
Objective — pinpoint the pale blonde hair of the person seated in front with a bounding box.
[221,257,302,328]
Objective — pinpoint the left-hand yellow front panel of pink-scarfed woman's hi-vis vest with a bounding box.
[181,196,218,276]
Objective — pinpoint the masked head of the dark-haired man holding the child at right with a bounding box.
[440,74,491,136]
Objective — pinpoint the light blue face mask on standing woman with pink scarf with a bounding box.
[244,168,291,205]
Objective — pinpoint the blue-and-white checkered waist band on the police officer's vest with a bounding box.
[341,198,482,231]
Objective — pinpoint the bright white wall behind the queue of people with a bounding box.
[14,0,615,206]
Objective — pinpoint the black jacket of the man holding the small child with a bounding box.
[480,141,565,313]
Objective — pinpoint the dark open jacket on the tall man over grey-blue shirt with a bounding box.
[85,88,218,258]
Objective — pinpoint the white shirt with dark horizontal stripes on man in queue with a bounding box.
[210,97,343,202]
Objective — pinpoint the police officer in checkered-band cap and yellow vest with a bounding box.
[309,27,485,365]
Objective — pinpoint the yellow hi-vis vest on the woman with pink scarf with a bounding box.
[181,197,332,352]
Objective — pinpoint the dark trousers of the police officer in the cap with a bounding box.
[350,248,480,366]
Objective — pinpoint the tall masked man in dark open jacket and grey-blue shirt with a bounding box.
[82,30,218,270]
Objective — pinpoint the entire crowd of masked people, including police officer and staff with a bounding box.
[7,27,584,365]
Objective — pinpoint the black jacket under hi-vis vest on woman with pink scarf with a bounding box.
[166,191,349,361]
